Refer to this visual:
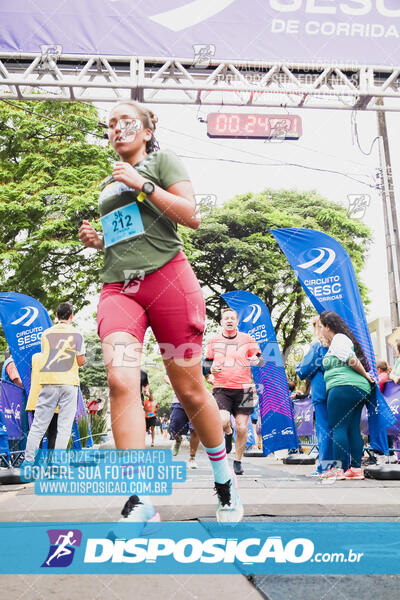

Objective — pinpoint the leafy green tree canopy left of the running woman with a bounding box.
[0,101,112,313]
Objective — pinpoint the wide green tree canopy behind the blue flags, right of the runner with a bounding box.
[185,189,370,353]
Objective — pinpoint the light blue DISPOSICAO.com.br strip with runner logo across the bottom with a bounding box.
[0,521,400,575]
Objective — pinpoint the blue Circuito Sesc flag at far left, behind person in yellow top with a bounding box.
[0,292,52,396]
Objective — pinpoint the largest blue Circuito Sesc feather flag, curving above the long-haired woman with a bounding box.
[271,228,396,454]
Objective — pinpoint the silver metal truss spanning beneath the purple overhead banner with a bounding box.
[0,53,400,111]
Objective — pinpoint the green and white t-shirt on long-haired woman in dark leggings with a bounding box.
[322,333,371,394]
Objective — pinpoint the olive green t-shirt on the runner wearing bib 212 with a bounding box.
[99,150,189,283]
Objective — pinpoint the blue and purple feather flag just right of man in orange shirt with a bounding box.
[222,290,299,456]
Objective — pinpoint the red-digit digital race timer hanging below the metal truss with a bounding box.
[207,113,302,140]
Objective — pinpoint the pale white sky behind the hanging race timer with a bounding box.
[77,103,400,328]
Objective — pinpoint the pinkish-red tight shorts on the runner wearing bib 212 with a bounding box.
[97,250,205,359]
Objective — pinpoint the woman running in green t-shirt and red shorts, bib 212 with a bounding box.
[79,101,243,522]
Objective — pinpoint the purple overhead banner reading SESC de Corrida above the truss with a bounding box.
[0,0,400,66]
